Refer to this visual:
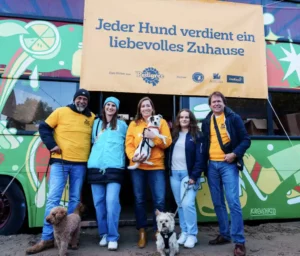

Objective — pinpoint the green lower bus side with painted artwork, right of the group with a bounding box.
[196,140,300,222]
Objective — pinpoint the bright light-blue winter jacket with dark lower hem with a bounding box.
[87,119,127,183]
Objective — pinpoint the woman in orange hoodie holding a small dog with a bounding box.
[125,97,172,248]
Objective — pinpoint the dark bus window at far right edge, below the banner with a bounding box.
[270,92,300,136]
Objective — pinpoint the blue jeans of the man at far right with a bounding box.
[207,161,245,244]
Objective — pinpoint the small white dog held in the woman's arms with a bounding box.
[128,115,167,170]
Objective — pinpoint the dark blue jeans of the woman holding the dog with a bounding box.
[130,169,166,230]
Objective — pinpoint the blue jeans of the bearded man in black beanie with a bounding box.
[42,163,86,240]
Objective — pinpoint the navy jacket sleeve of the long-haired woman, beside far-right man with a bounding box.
[190,134,208,181]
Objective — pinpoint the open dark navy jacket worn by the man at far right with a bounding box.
[202,107,251,170]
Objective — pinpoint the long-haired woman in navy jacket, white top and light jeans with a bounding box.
[169,109,207,248]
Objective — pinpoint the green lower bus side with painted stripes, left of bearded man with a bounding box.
[0,134,69,227]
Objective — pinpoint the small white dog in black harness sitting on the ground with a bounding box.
[155,210,179,256]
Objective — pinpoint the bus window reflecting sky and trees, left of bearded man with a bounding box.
[0,79,77,133]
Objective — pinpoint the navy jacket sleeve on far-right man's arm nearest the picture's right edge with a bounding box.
[233,115,251,158]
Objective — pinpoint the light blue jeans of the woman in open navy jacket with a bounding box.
[170,170,200,236]
